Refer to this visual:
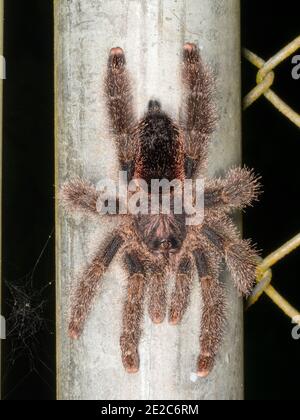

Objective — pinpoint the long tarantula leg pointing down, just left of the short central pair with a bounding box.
[120,252,146,373]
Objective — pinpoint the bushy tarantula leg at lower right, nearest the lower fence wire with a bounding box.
[201,216,258,296]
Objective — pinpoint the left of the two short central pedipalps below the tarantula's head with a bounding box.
[147,270,167,324]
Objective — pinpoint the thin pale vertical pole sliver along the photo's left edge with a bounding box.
[0,0,6,399]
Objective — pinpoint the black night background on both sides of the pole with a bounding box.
[2,0,300,400]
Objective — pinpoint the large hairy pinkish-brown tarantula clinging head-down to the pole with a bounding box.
[62,43,259,377]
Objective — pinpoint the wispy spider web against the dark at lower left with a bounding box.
[3,229,54,399]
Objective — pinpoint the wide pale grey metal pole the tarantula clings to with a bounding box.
[54,0,243,400]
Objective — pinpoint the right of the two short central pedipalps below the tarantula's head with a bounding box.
[169,257,192,325]
